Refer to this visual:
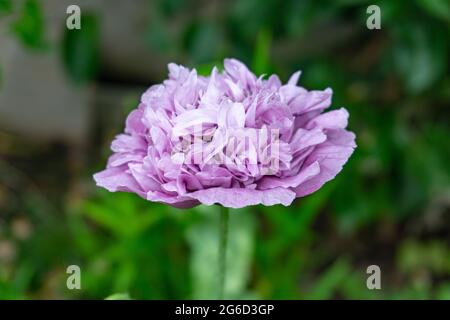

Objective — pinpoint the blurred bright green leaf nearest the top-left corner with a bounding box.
[11,0,45,49]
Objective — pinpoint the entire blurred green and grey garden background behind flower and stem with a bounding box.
[0,0,450,299]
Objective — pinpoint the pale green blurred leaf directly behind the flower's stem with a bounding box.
[187,207,255,299]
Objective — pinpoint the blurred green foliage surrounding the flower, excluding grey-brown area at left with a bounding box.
[0,0,450,299]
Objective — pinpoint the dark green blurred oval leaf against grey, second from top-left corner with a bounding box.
[62,12,100,84]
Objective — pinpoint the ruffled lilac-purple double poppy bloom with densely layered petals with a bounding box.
[94,59,356,208]
